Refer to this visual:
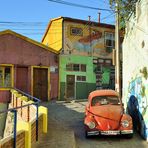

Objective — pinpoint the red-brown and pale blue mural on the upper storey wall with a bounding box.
[65,29,111,58]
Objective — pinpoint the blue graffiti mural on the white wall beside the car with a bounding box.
[127,67,148,139]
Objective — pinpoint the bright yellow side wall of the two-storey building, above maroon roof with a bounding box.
[43,18,63,51]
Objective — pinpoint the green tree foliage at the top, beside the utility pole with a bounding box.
[109,0,138,28]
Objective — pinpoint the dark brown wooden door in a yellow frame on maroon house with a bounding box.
[33,68,48,101]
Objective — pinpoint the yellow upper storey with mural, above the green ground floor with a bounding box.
[42,17,115,59]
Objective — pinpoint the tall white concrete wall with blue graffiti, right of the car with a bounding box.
[123,0,148,140]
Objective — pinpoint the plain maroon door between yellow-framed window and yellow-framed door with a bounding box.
[16,67,28,93]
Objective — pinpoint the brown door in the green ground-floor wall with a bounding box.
[66,75,75,98]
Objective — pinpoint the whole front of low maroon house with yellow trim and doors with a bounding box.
[0,30,58,103]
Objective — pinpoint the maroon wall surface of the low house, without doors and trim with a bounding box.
[0,34,58,100]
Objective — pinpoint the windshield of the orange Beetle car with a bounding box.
[91,96,120,106]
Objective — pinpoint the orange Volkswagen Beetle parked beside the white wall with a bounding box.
[84,90,133,138]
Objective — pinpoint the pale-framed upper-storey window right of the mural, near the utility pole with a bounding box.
[105,32,115,47]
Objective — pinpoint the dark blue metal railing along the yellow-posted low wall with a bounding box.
[0,88,41,148]
